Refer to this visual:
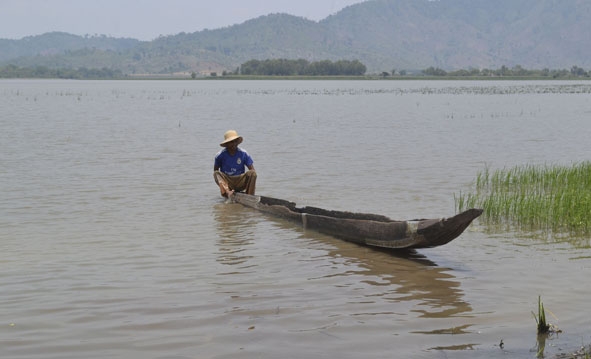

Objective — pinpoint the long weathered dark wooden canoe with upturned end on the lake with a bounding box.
[232,193,482,249]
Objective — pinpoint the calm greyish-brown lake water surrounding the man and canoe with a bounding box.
[0,80,591,359]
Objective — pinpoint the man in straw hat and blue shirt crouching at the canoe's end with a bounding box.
[213,130,257,198]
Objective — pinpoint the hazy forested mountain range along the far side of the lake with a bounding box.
[0,0,591,74]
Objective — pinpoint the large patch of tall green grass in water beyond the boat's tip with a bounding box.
[455,162,591,234]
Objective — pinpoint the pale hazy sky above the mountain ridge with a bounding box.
[0,0,364,40]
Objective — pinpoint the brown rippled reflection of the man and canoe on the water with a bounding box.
[216,204,472,320]
